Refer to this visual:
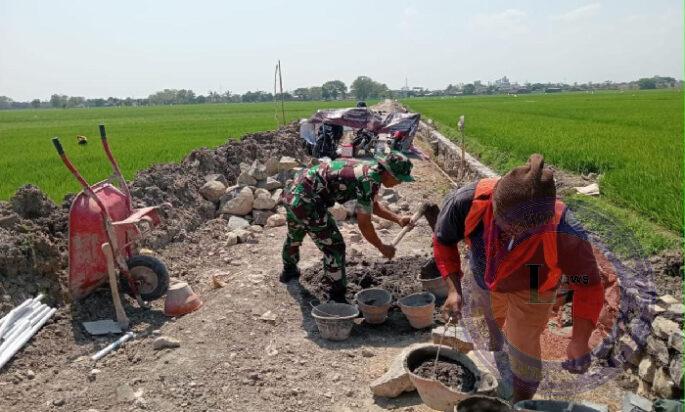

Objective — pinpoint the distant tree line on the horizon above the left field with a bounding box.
[0,76,392,109]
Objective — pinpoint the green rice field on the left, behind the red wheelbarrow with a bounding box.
[0,101,354,201]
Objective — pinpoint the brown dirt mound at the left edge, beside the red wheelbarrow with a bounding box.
[0,185,68,313]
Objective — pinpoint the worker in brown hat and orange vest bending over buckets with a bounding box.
[433,154,604,401]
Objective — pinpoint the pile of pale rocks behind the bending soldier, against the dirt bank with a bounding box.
[199,156,301,243]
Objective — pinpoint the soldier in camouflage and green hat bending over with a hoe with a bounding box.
[280,152,414,302]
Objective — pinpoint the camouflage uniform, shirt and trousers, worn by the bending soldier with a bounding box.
[283,159,381,288]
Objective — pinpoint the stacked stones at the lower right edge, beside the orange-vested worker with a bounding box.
[595,288,685,399]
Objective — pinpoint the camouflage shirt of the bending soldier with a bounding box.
[287,159,381,214]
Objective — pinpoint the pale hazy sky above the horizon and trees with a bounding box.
[0,0,683,100]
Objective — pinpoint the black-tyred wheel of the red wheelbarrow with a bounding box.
[120,255,169,302]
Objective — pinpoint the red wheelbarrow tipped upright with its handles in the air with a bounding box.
[52,124,171,329]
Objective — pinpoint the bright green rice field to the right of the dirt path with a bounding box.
[403,91,683,236]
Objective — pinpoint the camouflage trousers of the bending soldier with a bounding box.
[282,204,346,286]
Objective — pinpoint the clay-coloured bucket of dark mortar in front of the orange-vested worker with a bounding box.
[404,345,498,411]
